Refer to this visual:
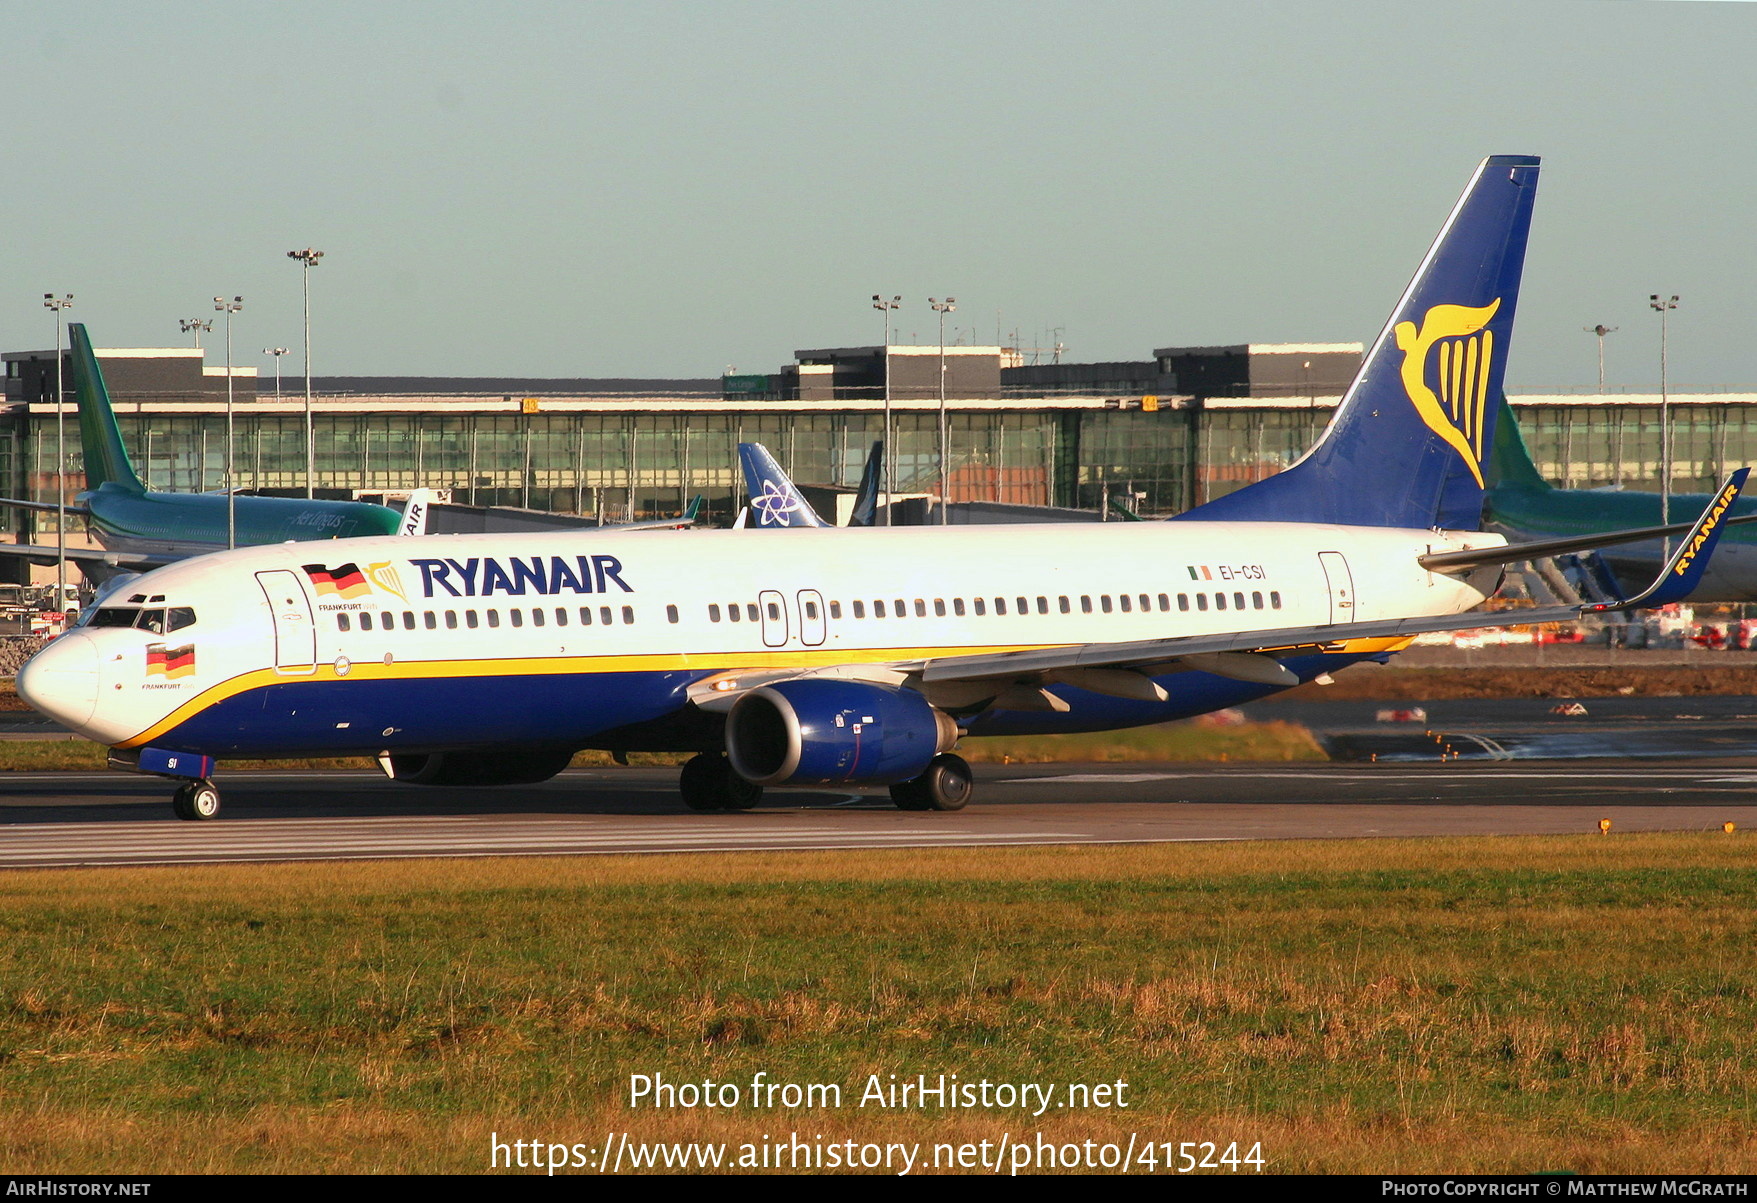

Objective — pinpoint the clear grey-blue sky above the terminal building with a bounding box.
[0,0,1757,390]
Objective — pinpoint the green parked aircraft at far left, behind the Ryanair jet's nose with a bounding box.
[0,321,402,581]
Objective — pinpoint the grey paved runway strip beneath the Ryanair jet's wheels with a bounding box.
[0,759,1757,868]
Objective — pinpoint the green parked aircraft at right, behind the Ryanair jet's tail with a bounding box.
[1483,399,1757,602]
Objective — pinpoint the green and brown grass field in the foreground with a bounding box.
[0,834,1757,1173]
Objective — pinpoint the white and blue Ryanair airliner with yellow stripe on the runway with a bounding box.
[18,156,1741,818]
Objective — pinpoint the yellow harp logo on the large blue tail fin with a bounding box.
[1395,297,1500,485]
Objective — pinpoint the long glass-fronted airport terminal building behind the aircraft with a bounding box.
[0,335,1757,551]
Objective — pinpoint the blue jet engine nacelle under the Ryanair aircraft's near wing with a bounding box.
[726,678,958,785]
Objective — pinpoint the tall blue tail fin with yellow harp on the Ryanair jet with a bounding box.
[1179,155,1537,530]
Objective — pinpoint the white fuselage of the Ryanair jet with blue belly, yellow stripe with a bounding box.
[19,522,1500,755]
